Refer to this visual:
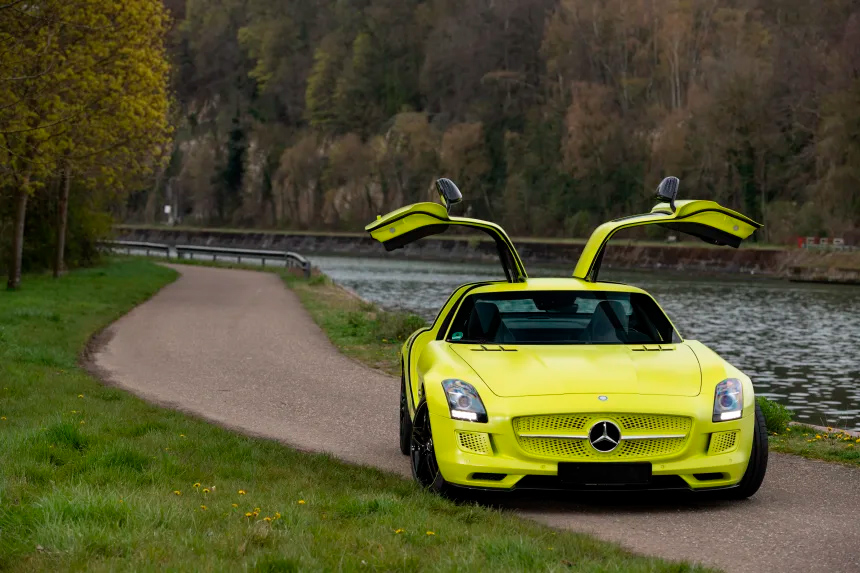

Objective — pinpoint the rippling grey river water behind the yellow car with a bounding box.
[313,257,860,429]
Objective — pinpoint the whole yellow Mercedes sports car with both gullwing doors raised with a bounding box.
[366,177,767,498]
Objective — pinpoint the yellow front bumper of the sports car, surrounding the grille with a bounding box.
[431,395,754,490]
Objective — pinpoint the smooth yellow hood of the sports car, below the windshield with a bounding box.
[451,344,702,397]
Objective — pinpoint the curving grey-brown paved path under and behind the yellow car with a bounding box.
[95,266,860,573]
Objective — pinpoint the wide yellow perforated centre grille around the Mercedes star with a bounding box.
[513,413,692,460]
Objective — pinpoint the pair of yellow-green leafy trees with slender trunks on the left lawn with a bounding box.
[0,0,168,289]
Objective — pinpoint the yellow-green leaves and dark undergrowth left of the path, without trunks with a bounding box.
[0,0,171,288]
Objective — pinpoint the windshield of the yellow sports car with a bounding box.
[448,291,680,344]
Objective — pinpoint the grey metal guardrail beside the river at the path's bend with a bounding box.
[100,241,311,278]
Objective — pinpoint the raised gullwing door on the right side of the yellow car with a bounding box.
[573,177,762,282]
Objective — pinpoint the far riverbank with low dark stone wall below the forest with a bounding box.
[115,225,860,284]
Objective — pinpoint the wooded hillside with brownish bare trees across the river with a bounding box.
[133,0,860,243]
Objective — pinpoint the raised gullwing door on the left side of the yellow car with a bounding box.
[364,179,528,282]
